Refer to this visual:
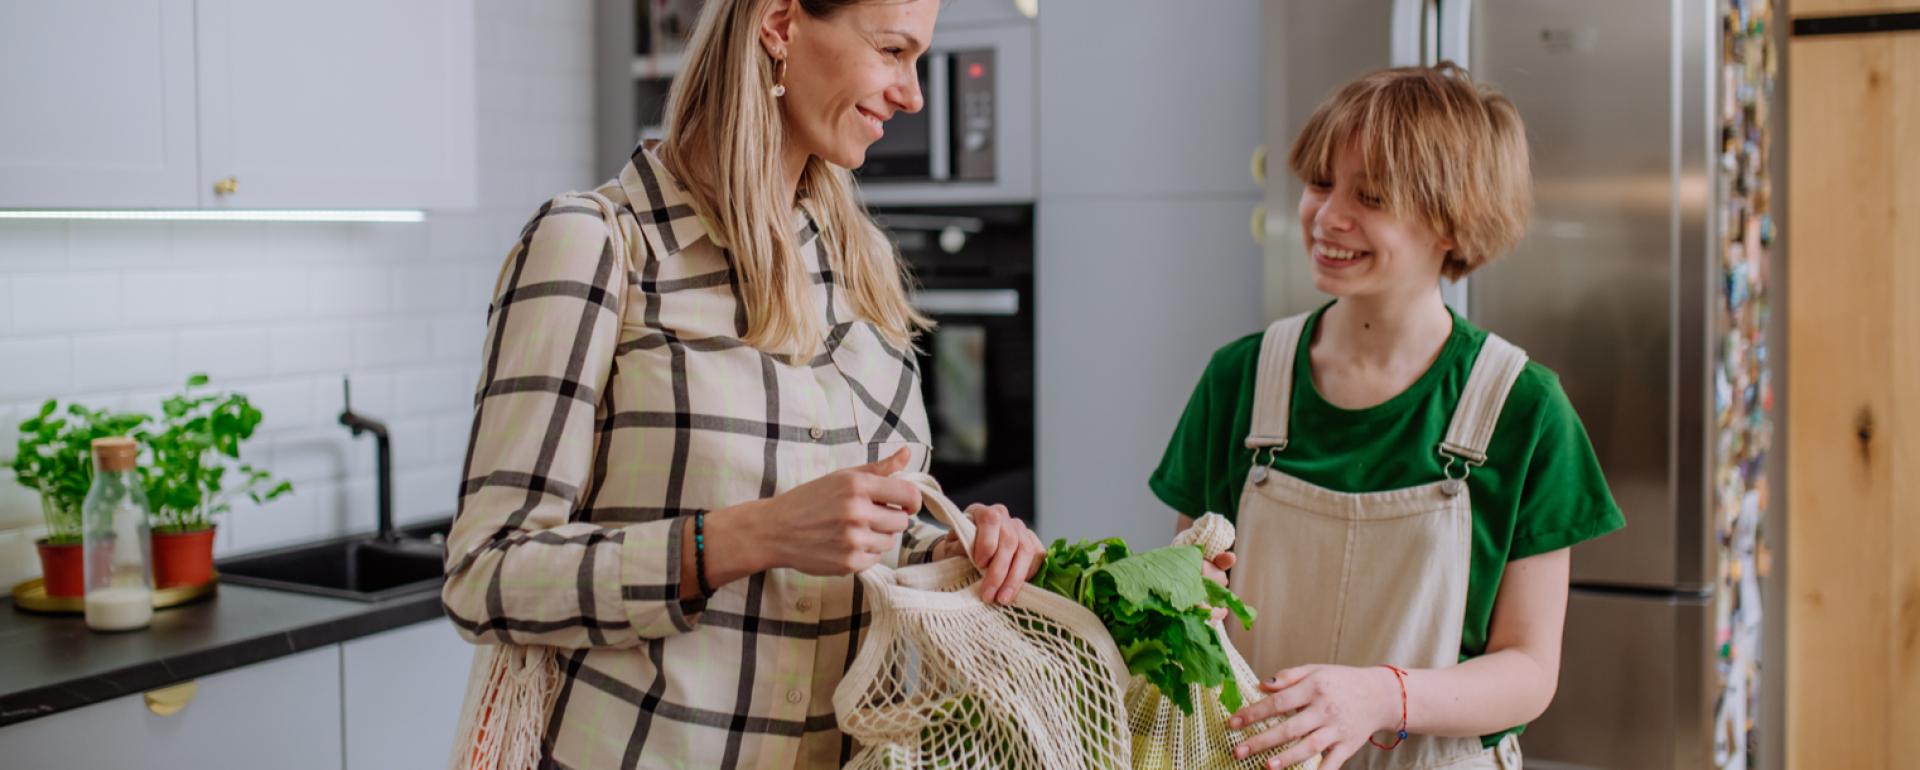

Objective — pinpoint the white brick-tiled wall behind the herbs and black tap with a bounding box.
[0,0,595,588]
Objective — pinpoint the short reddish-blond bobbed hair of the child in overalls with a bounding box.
[1286,61,1532,280]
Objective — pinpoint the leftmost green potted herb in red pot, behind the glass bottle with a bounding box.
[13,399,148,597]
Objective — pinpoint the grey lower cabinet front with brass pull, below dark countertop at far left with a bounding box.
[0,647,341,770]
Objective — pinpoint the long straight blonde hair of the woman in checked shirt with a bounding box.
[660,0,931,355]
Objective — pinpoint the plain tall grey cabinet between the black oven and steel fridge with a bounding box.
[1035,0,1263,547]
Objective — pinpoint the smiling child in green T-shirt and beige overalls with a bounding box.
[1150,65,1622,770]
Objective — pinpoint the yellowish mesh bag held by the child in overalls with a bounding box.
[1127,513,1319,770]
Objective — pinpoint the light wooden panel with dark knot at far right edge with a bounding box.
[1786,30,1920,770]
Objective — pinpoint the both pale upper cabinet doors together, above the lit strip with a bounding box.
[0,0,476,209]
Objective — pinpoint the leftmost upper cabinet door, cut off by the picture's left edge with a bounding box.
[0,0,200,209]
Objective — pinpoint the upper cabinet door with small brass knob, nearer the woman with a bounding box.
[198,0,474,209]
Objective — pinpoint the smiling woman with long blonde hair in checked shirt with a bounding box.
[444,0,1044,768]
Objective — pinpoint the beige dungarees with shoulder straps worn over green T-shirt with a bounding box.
[1227,315,1526,770]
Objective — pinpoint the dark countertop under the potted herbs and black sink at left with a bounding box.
[0,584,442,726]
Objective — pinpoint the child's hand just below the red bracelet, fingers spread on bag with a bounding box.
[1227,666,1400,770]
